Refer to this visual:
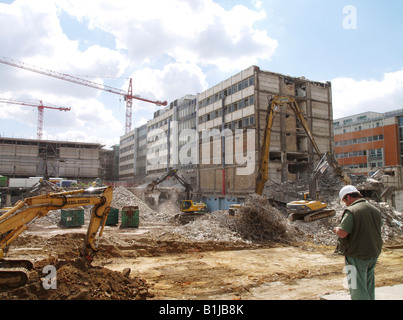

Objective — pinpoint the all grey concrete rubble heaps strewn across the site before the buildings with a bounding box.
[34,187,403,246]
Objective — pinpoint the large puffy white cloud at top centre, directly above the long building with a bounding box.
[54,0,277,71]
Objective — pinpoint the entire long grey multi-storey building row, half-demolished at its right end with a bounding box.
[120,66,334,210]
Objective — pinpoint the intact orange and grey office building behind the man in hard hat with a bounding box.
[333,110,403,175]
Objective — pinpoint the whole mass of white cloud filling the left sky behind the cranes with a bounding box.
[0,0,277,139]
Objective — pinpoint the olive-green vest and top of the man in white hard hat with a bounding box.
[339,199,383,260]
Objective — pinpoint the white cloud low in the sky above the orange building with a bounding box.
[332,69,403,119]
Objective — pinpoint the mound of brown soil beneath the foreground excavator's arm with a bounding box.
[0,257,152,300]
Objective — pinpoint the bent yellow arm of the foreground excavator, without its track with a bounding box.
[0,186,113,261]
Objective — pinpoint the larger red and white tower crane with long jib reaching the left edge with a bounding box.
[0,57,168,133]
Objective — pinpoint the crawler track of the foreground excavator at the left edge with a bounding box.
[0,260,33,288]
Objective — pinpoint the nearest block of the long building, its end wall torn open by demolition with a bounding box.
[197,66,334,210]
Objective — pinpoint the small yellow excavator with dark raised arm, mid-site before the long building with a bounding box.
[147,169,207,223]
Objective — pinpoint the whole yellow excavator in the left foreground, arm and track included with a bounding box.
[0,186,113,288]
